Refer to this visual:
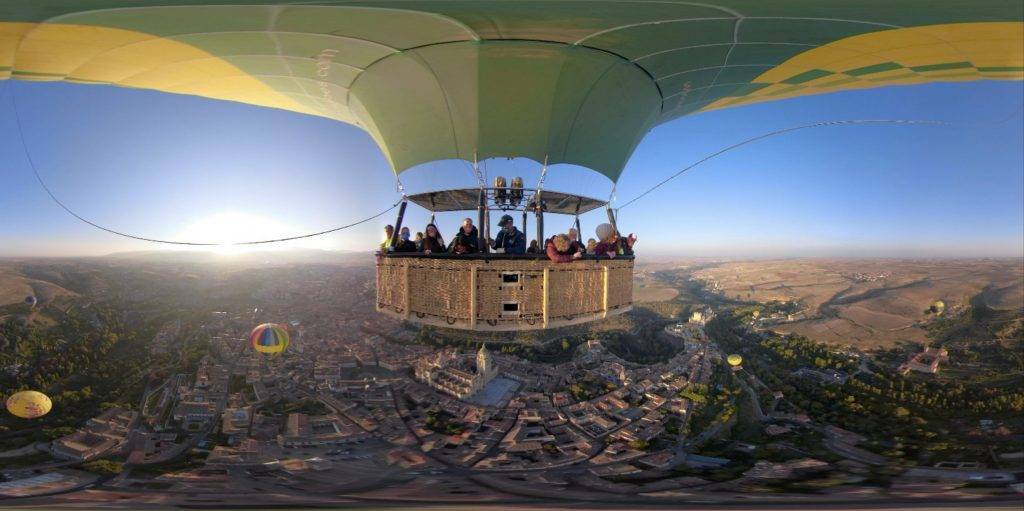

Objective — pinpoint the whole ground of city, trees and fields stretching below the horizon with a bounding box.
[0,254,1024,509]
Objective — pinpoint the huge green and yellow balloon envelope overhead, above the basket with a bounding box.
[0,0,1024,181]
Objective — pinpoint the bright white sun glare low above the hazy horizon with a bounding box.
[174,212,328,254]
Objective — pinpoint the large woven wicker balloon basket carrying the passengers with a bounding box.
[377,256,633,331]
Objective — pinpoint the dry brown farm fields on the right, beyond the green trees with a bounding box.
[693,259,1024,348]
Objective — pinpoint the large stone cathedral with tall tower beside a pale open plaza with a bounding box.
[415,345,498,399]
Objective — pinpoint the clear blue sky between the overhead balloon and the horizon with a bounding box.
[0,81,1024,257]
